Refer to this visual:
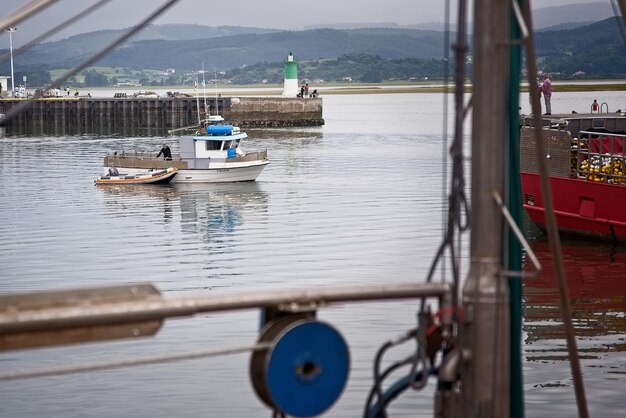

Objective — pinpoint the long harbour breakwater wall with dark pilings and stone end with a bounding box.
[0,96,324,135]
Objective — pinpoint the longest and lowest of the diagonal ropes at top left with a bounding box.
[4,0,179,121]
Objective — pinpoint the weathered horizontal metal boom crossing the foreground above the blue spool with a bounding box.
[0,283,451,336]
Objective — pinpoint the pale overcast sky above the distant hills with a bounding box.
[0,0,609,48]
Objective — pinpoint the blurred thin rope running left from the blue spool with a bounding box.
[0,342,272,382]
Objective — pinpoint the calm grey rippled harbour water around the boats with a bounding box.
[0,93,626,418]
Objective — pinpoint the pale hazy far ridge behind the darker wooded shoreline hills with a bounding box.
[9,2,613,71]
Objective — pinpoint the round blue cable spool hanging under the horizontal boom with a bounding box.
[251,318,350,417]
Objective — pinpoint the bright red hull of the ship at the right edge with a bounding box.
[521,172,626,242]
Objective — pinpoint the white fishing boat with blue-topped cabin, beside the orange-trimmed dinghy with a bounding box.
[103,115,269,183]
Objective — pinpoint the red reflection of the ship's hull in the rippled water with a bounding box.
[523,240,626,361]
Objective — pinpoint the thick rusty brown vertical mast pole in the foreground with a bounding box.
[461,0,510,418]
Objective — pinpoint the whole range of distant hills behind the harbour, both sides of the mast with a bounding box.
[0,3,626,83]
